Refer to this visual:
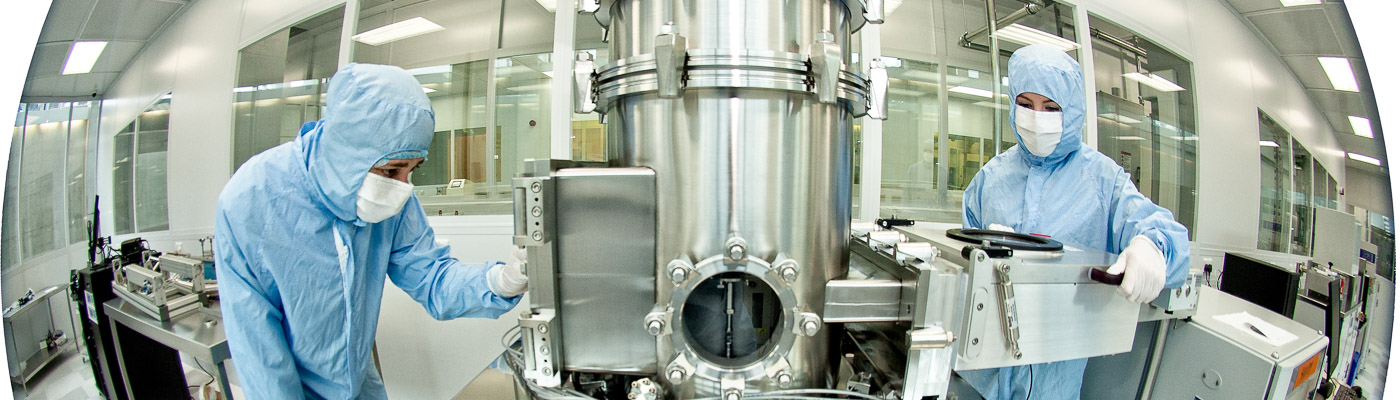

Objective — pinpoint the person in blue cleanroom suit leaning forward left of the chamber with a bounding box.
[214,64,525,399]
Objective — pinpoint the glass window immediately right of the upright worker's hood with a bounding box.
[1086,15,1200,238]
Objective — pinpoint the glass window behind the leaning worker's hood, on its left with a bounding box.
[234,6,344,171]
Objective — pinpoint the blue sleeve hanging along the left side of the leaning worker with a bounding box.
[214,205,304,399]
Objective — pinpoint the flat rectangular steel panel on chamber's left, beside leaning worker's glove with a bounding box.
[554,168,657,373]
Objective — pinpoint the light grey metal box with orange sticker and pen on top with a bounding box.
[1152,287,1327,400]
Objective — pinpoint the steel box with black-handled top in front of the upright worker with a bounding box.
[897,222,1141,371]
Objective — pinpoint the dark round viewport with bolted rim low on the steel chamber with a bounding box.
[680,273,783,366]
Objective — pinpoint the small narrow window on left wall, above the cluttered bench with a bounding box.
[112,94,171,235]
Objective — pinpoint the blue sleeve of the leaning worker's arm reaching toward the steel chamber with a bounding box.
[389,196,521,320]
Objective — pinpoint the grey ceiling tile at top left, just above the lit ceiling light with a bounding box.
[78,0,182,41]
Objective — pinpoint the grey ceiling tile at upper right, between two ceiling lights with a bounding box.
[1246,7,1344,56]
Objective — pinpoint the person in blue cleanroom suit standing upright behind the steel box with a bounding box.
[959,45,1189,399]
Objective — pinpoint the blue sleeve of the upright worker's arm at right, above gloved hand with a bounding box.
[1107,165,1191,288]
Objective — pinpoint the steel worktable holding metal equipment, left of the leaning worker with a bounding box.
[102,298,234,399]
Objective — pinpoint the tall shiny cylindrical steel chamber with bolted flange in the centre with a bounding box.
[592,0,868,397]
